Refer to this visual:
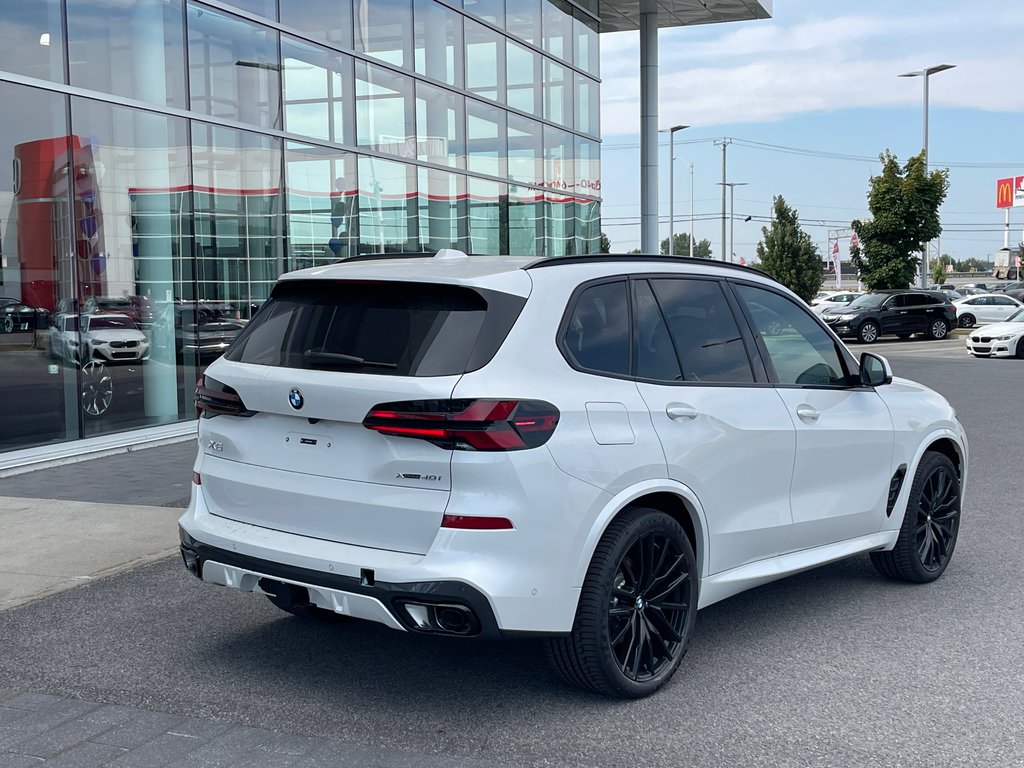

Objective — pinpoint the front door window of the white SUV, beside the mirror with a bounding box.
[735,285,847,386]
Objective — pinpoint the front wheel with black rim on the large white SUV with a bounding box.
[870,452,961,584]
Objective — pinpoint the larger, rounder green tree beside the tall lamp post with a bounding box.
[850,150,949,290]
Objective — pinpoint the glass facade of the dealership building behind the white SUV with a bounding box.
[0,0,601,452]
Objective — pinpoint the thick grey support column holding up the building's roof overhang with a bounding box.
[640,0,658,254]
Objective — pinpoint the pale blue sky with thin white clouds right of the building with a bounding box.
[601,0,1024,261]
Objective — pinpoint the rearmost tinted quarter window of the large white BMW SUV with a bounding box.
[562,281,630,376]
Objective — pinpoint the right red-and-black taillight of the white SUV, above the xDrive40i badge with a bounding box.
[362,399,558,451]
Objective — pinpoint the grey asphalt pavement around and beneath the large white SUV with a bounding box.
[0,338,1024,768]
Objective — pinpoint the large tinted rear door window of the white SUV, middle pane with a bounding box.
[650,278,754,384]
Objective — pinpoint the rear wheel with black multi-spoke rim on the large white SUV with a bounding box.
[548,507,698,698]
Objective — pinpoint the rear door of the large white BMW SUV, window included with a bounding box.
[633,278,796,573]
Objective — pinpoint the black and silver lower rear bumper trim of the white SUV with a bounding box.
[178,526,509,638]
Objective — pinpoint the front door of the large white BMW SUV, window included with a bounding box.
[735,284,895,551]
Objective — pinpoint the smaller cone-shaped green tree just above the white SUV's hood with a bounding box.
[758,195,821,301]
